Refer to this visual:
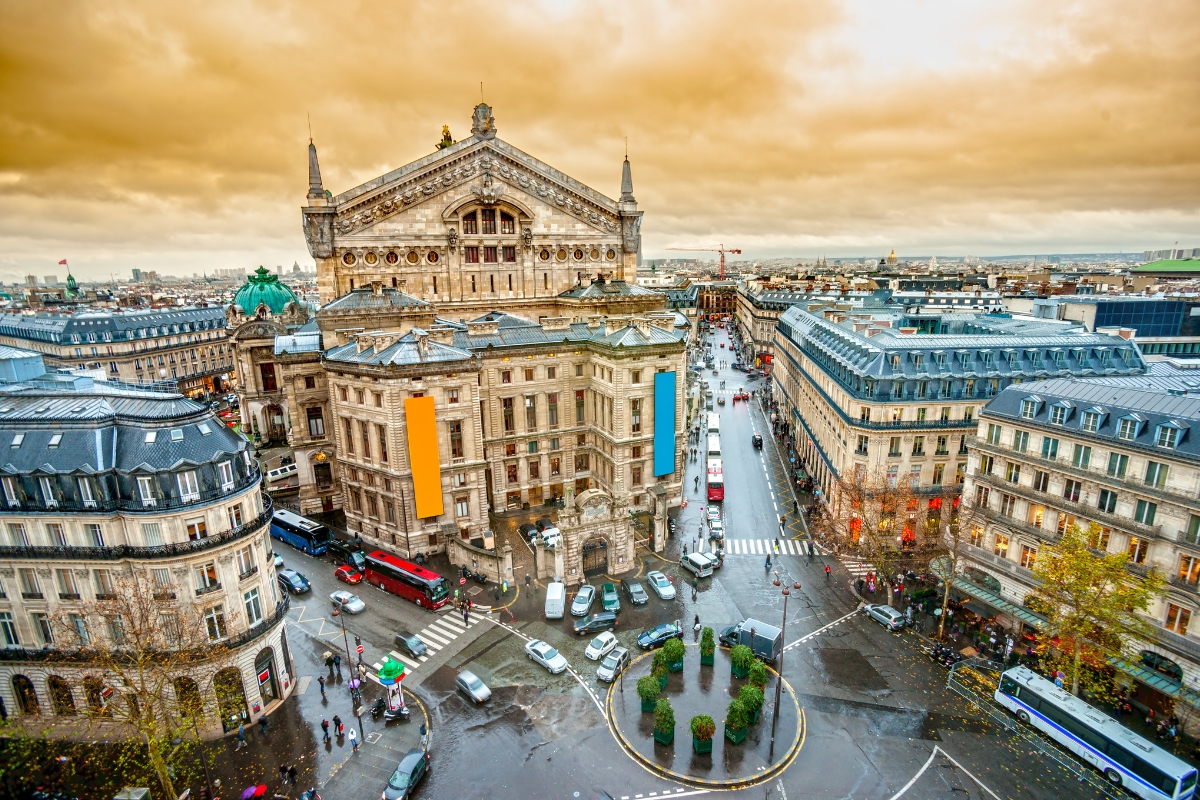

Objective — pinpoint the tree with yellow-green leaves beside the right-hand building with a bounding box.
[1033,523,1165,694]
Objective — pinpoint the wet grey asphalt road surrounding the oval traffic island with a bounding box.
[274,331,1113,800]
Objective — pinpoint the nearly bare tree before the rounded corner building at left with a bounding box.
[48,569,234,798]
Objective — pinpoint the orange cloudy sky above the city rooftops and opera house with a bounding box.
[0,0,1200,281]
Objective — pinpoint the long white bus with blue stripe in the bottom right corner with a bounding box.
[995,667,1196,800]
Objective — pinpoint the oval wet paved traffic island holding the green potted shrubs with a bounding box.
[606,644,804,789]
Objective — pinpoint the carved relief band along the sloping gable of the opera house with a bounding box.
[334,148,620,236]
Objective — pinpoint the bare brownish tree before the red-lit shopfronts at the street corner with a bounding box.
[811,470,954,602]
